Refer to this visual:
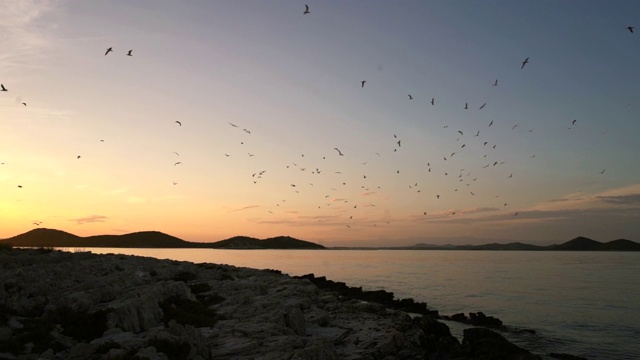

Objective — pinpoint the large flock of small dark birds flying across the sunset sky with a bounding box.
[0,5,634,228]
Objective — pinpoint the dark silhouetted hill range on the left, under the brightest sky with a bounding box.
[0,228,324,249]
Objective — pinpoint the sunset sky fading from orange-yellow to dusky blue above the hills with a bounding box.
[0,0,640,246]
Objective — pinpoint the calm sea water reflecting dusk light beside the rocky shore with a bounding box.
[71,248,640,359]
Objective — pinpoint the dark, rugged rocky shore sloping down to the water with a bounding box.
[0,248,584,360]
